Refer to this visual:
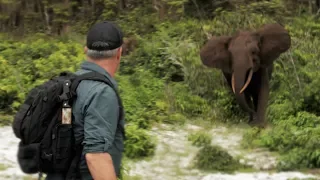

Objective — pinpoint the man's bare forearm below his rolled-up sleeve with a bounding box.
[86,153,117,180]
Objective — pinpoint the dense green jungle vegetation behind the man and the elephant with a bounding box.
[0,0,320,178]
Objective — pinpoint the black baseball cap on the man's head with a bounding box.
[87,21,123,51]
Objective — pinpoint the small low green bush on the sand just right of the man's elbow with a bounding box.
[125,124,156,158]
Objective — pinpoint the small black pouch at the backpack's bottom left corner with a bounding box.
[18,142,40,174]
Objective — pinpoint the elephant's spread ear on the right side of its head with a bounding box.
[257,23,291,66]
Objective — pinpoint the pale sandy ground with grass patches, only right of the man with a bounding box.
[129,125,320,180]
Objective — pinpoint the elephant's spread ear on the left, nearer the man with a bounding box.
[200,36,231,72]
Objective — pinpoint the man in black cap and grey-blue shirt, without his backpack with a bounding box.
[48,22,124,180]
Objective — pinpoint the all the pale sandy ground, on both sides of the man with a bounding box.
[0,125,320,180]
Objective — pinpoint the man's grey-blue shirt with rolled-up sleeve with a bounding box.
[72,61,124,180]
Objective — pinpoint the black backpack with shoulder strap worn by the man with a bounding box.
[12,72,125,179]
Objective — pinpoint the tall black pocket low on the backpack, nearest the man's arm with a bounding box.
[54,124,75,171]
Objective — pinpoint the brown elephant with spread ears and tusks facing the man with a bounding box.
[200,23,291,128]
